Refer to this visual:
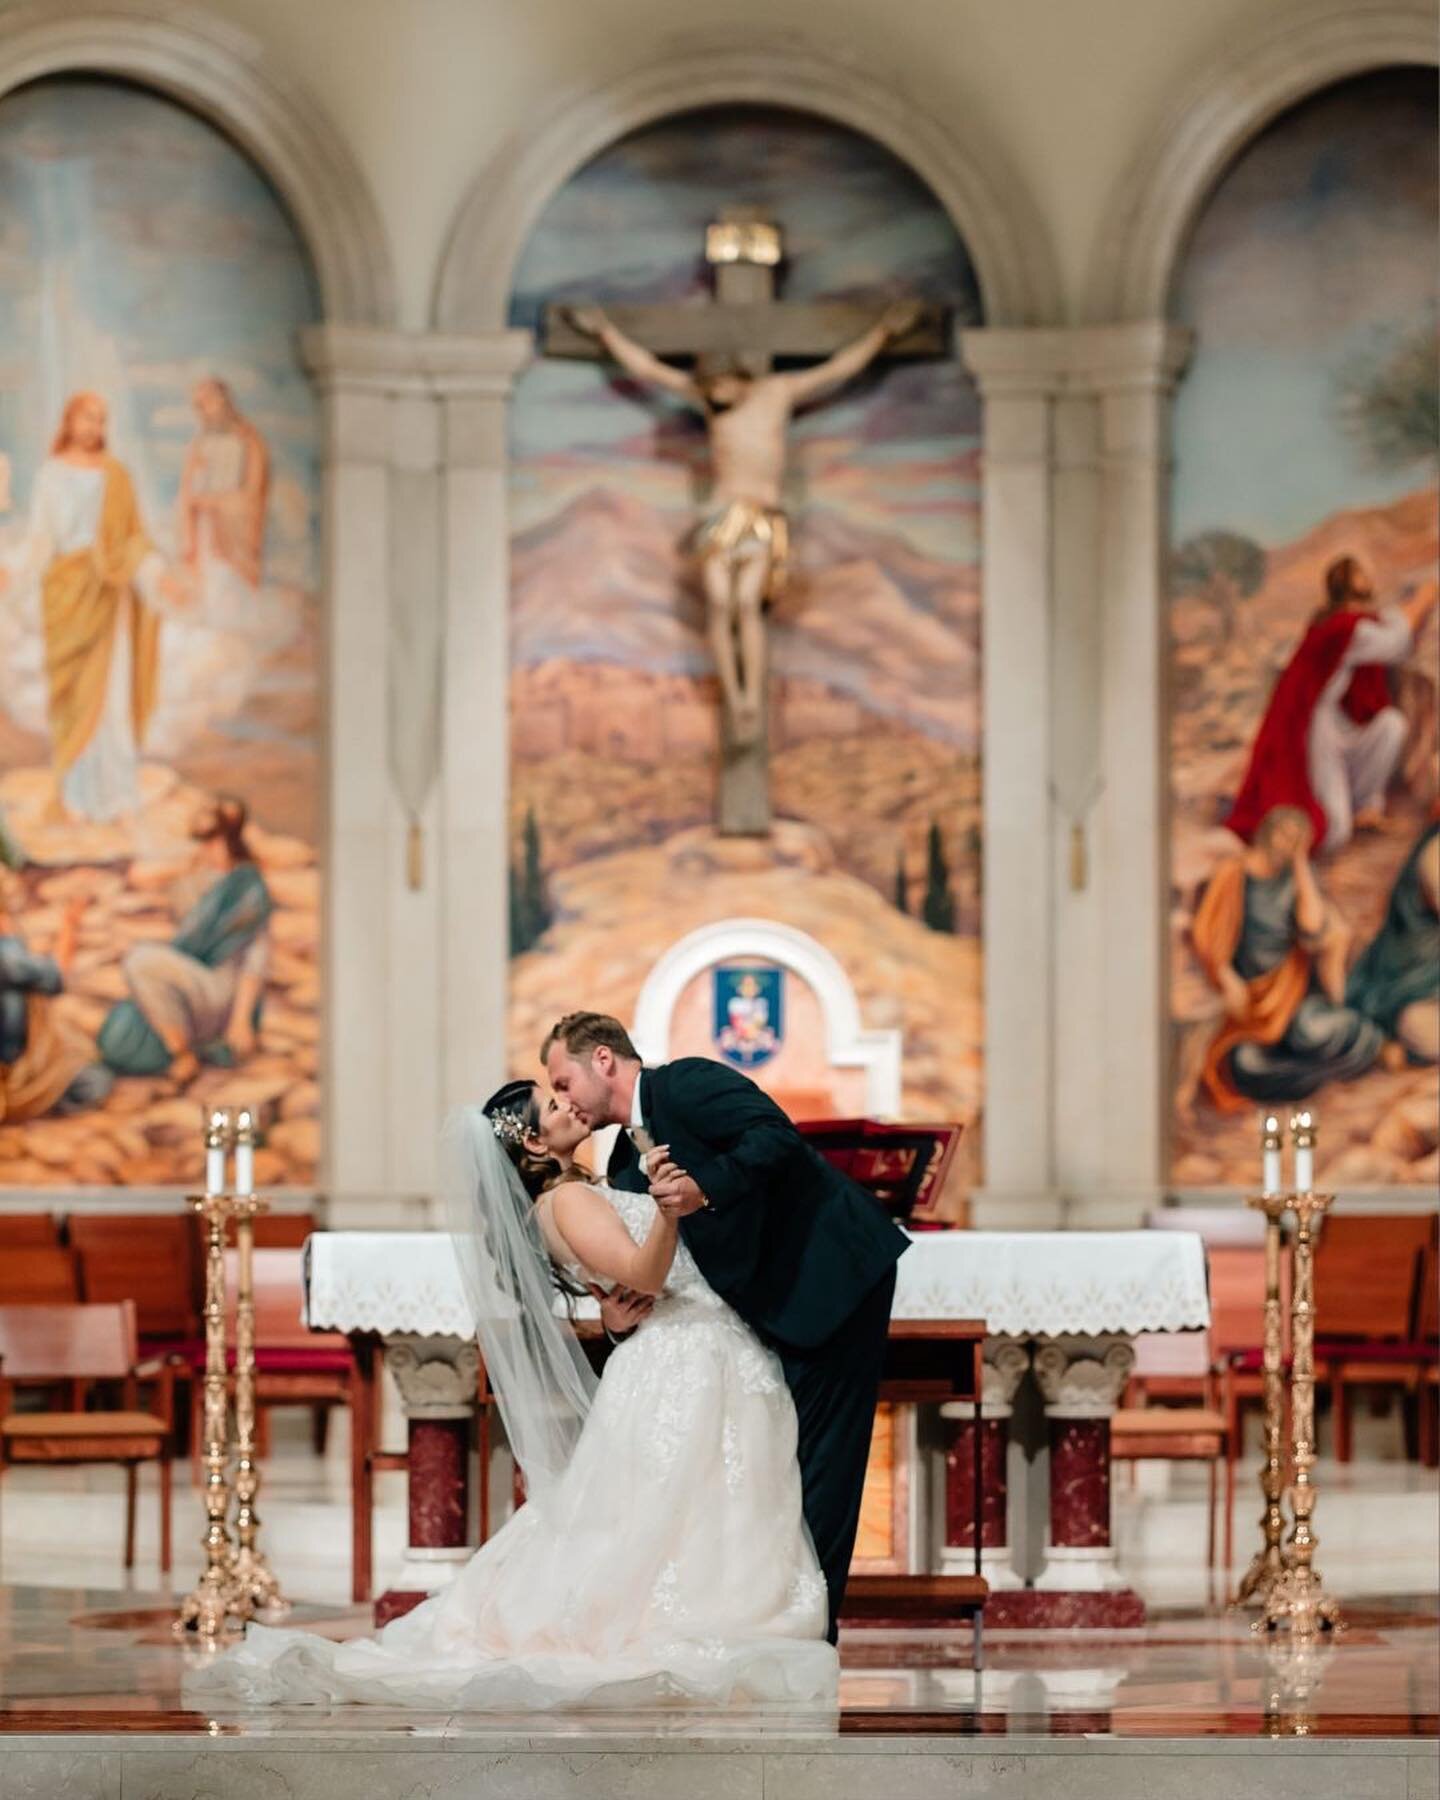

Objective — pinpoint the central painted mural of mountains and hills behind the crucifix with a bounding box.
[509,108,983,1175]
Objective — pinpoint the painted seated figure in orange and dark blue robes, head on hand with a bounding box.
[1192,806,1384,1112]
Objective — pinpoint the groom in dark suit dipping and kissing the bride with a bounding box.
[540,1012,907,1643]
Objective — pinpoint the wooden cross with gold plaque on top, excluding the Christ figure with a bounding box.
[544,207,947,837]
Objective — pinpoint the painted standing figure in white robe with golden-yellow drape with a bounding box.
[0,392,185,824]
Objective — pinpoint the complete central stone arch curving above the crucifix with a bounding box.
[434,38,1060,333]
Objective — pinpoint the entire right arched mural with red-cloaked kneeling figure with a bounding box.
[1170,68,1440,1186]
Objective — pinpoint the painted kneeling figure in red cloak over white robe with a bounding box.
[1226,556,1440,853]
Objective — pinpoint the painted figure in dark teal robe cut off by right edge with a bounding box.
[1345,801,1440,1067]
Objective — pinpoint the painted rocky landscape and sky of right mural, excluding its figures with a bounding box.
[1170,70,1440,1188]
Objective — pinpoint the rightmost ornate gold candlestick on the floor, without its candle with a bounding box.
[1253,1193,1341,1638]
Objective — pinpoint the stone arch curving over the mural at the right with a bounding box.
[1085,0,1436,324]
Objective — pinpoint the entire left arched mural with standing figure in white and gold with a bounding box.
[0,77,320,1188]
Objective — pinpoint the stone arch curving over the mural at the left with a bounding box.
[0,0,396,326]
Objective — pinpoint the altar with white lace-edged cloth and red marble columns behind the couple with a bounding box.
[306,1231,1210,1627]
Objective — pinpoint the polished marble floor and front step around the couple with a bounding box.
[0,1420,1440,1800]
